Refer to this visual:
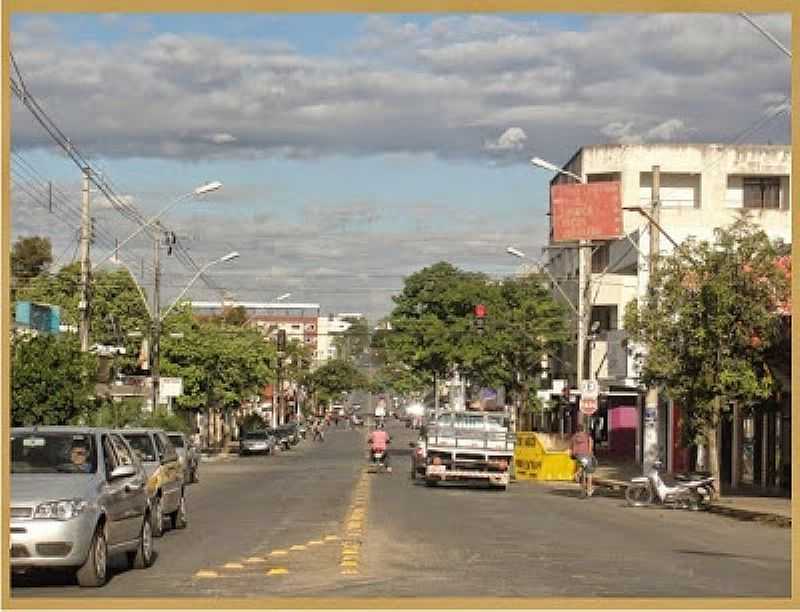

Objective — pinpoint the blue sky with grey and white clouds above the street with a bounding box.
[11,14,791,318]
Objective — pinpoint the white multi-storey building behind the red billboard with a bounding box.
[546,144,791,478]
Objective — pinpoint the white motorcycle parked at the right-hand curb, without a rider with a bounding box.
[625,461,714,510]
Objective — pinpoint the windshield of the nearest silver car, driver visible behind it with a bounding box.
[11,432,97,474]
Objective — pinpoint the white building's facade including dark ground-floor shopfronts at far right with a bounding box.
[546,144,791,488]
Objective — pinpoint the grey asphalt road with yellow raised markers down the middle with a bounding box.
[12,424,791,598]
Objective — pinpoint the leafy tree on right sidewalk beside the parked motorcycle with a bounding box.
[625,220,790,490]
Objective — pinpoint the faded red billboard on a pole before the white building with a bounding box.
[550,181,623,242]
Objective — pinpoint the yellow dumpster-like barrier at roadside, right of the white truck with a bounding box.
[514,431,577,480]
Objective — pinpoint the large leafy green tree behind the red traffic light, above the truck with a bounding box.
[380,262,568,418]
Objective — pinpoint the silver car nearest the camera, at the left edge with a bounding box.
[10,427,153,587]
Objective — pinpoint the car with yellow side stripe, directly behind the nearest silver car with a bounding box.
[119,429,188,537]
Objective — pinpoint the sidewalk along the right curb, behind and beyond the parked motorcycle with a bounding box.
[593,460,792,527]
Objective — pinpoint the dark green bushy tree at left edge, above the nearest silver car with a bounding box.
[11,334,97,426]
